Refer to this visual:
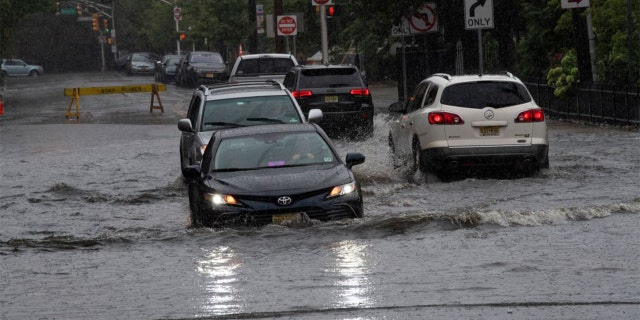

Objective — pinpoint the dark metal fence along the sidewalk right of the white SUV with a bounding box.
[523,79,640,127]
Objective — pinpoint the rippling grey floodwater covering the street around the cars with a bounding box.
[0,74,640,320]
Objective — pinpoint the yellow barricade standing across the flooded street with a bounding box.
[64,83,167,118]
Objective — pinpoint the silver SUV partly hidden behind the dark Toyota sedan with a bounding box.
[178,81,322,173]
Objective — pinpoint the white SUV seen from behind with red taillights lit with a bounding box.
[389,73,549,177]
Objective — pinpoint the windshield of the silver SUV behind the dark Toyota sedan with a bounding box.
[201,95,302,131]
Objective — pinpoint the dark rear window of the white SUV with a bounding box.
[440,81,531,109]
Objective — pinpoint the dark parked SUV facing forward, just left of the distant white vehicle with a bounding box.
[176,51,229,87]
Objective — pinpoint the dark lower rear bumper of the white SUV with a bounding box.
[422,144,549,171]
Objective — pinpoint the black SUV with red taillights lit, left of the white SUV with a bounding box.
[283,65,373,138]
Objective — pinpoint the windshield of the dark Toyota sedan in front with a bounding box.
[212,132,336,171]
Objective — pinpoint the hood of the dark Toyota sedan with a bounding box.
[207,164,353,196]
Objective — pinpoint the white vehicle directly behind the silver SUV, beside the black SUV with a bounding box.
[229,53,298,82]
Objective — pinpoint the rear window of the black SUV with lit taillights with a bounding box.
[300,68,362,88]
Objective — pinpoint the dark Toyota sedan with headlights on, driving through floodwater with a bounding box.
[186,124,365,227]
